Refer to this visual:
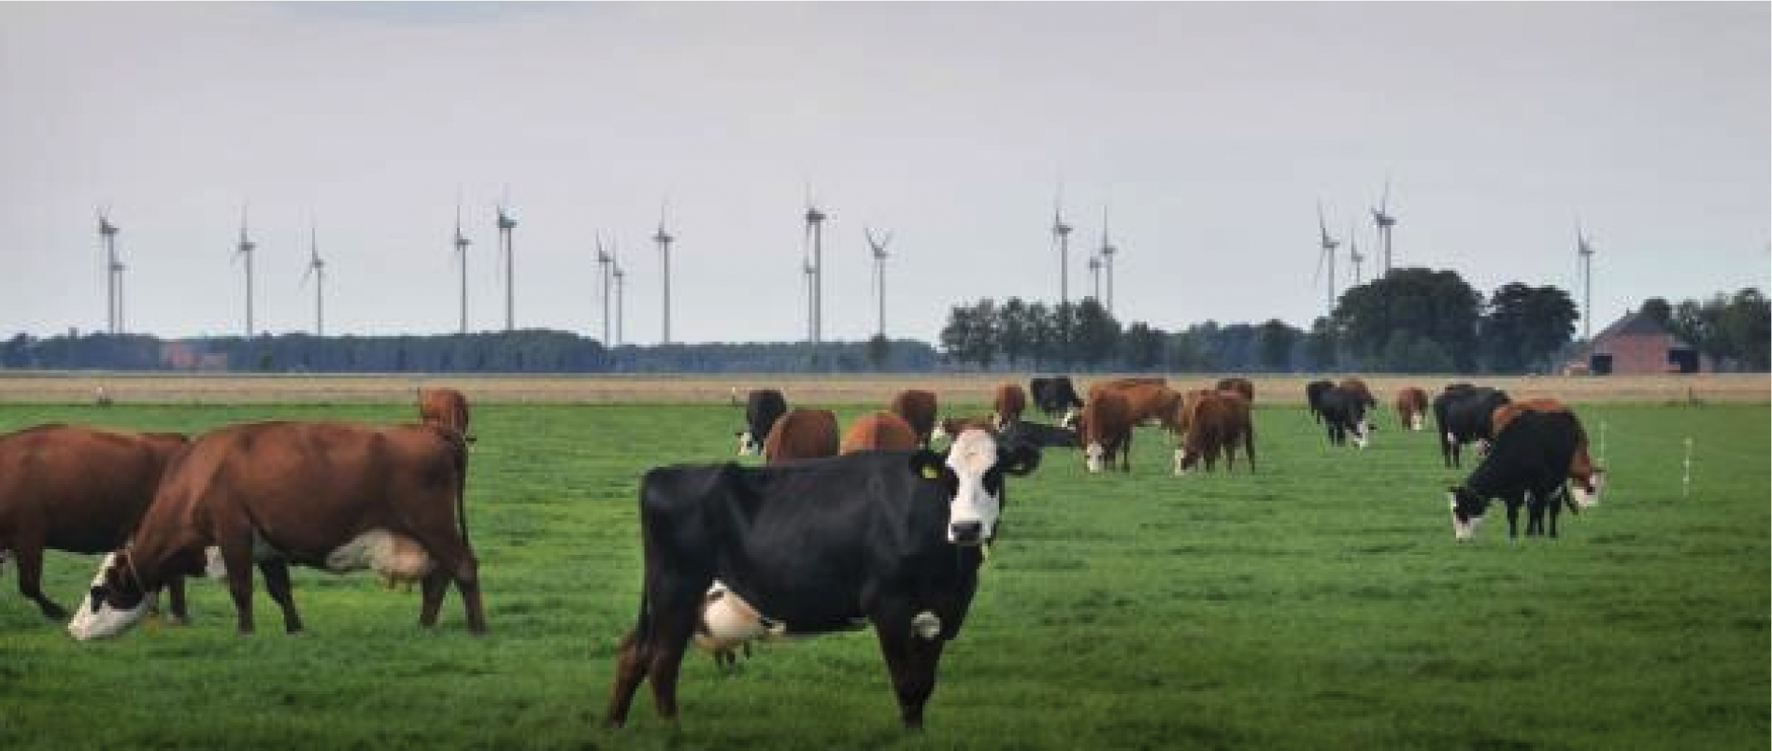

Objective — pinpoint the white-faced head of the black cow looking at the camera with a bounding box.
[911,429,1040,546]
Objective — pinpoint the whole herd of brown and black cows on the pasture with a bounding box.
[0,376,1604,728]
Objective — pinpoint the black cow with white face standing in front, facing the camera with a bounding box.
[604,430,1040,728]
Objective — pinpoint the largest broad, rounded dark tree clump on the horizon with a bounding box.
[1334,269,1483,372]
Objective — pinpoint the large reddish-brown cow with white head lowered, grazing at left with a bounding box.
[69,422,486,639]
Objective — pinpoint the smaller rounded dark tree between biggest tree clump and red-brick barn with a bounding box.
[1478,282,1581,372]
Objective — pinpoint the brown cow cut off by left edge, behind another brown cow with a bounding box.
[0,425,188,620]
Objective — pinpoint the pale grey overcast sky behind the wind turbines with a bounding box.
[0,2,1772,344]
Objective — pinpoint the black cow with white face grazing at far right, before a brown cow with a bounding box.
[1448,411,1582,540]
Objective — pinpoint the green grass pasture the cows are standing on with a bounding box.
[0,404,1772,749]
